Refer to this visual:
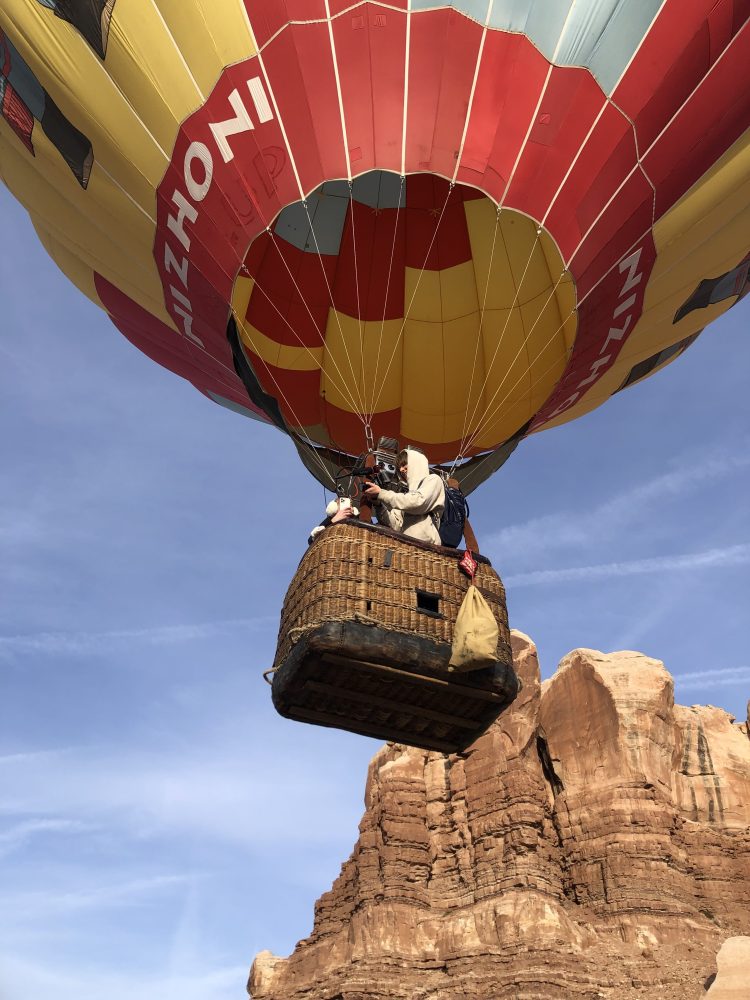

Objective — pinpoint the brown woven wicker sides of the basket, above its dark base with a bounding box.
[274,523,511,666]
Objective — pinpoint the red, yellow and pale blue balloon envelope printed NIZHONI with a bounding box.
[0,0,750,748]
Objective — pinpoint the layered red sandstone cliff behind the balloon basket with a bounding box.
[248,633,750,1000]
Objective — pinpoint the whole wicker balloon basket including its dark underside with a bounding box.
[273,521,517,751]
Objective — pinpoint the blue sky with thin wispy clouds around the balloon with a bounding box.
[0,182,750,1000]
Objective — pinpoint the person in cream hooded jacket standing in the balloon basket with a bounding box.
[363,448,445,545]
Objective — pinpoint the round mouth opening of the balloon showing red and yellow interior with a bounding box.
[232,170,576,462]
